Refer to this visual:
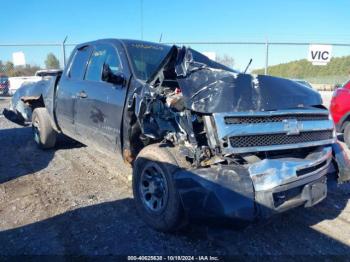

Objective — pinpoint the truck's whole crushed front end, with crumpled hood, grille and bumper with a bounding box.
[125,47,336,221]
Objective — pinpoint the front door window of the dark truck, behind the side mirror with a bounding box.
[85,45,122,81]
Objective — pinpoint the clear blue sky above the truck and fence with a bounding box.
[0,0,350,68]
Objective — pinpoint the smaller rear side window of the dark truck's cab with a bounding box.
[68,46,91,79]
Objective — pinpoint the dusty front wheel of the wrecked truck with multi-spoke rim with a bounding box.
[132,144,185,232]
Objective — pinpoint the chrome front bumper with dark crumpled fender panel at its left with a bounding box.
[175,147,332,221]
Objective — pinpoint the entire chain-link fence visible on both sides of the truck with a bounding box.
[0,39,350,94]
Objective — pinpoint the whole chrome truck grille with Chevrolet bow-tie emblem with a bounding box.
[209,109,335,154]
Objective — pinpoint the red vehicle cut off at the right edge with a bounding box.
[330,80,350,148]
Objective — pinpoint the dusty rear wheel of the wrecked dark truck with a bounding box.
[32,107,57,149]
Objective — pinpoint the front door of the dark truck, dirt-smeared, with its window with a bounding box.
[75,44,127,152]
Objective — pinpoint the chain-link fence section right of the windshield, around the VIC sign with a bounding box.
[168,42,350,91]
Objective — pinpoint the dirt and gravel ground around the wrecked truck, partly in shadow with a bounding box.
[0,96,350,256]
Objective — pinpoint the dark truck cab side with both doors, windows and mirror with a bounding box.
[55,42,131,152]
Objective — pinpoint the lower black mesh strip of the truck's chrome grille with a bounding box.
[229,130,333,148]
